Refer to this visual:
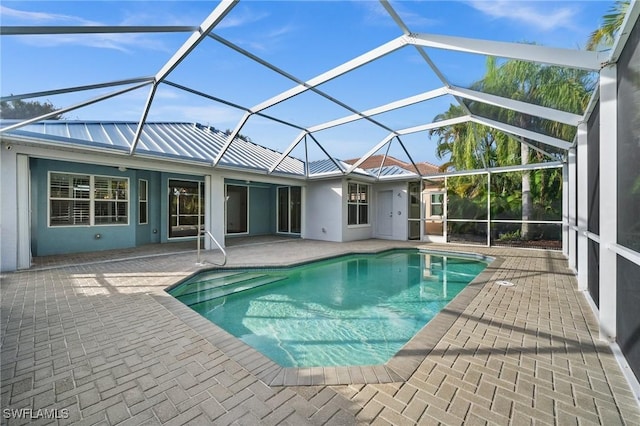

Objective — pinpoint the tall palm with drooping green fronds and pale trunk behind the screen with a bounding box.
[431,54,595,239]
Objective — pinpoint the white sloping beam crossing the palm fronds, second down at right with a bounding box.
[446,86,582,126]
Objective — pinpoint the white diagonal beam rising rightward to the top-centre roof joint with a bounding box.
[251,36,407,112]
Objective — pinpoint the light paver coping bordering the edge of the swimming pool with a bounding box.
[151,247,503,386]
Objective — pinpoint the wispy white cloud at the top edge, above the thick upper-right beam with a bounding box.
[468,0,578,31]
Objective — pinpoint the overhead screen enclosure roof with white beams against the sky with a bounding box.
[0,1,612,172]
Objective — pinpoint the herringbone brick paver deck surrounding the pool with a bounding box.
[0,240,640,426]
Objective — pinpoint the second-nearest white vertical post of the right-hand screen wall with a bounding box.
[576,123,589,291]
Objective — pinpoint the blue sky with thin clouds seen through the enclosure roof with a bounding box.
[0,0,613,163]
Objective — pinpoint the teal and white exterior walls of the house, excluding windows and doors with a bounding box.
[0,137,416,271]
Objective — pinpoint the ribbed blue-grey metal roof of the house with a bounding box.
[2,120,406,178]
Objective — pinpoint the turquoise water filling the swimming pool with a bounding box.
[169,250,487,367]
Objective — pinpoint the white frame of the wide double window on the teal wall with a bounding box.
[47,170,131,228]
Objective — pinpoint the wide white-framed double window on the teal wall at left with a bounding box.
[49,172,129,226]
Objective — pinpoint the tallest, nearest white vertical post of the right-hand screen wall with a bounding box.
[599,64,618,342]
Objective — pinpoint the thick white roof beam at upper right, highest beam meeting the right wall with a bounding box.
[408,34,606,71]
